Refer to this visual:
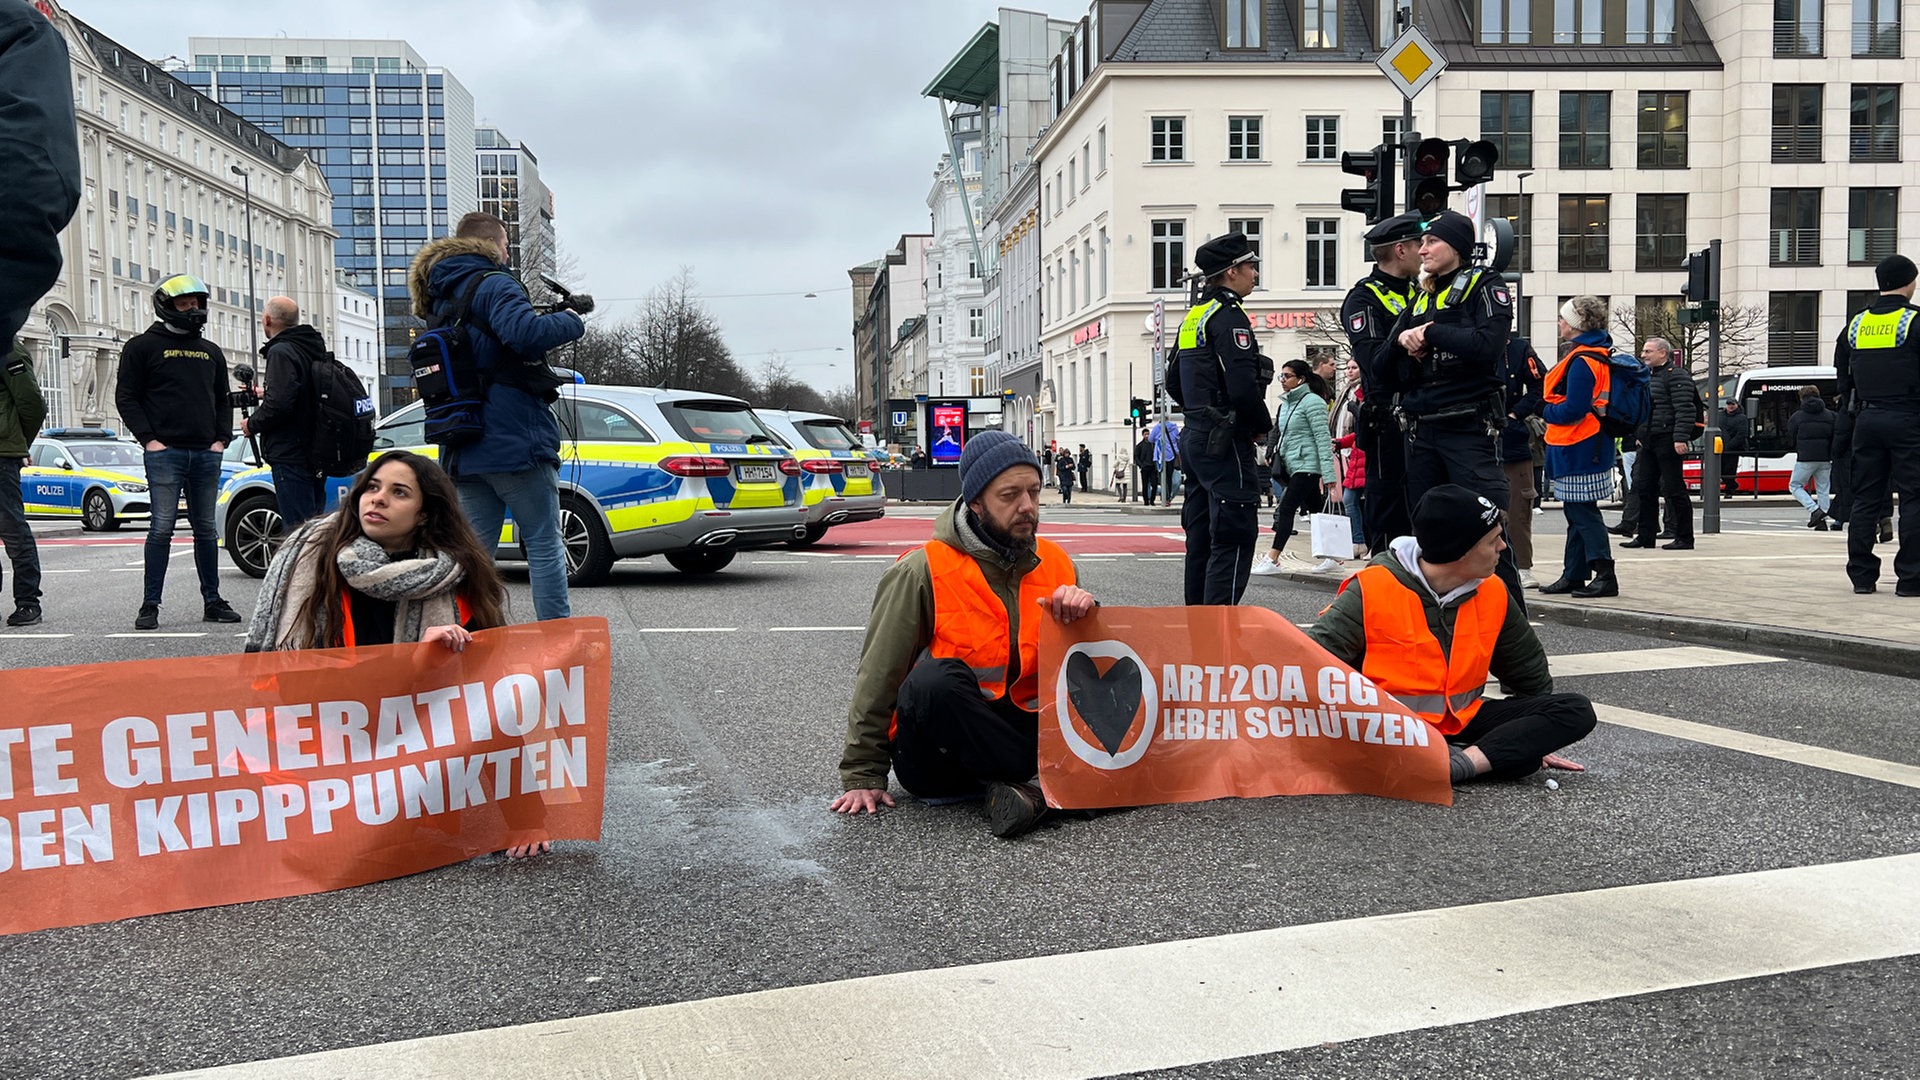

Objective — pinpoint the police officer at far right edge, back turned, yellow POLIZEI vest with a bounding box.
[1834,256,1920,596]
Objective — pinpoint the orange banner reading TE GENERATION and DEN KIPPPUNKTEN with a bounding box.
[0,619,611,934]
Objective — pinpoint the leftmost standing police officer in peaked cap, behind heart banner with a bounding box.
[1167,233,1273,603]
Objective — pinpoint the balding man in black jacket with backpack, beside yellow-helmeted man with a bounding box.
[240,296,326,536]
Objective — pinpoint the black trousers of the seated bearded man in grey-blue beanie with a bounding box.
[893,657,1041,799]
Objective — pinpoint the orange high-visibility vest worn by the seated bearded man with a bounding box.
[924,538,1073,713]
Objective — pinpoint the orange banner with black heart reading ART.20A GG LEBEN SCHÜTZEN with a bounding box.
[1041,607,1453,809]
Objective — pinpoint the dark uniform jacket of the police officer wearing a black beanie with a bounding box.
[1384,267,1513,417]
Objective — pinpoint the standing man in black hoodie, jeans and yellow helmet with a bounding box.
[113,273,240,630]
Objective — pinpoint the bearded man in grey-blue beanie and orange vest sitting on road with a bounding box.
[831,430,1096,836]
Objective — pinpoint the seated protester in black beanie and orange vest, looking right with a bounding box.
[1308,484,1594,784]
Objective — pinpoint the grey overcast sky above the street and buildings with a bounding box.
[97,0,1013,390]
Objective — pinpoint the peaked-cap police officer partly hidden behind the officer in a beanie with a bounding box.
[1340,213,1421,555]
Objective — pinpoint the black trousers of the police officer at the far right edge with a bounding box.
[1847,405,1920,594]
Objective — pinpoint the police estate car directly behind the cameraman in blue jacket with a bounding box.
[213,384,806,586]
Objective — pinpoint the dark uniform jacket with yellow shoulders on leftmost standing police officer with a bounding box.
[1175,284,1273,438]
